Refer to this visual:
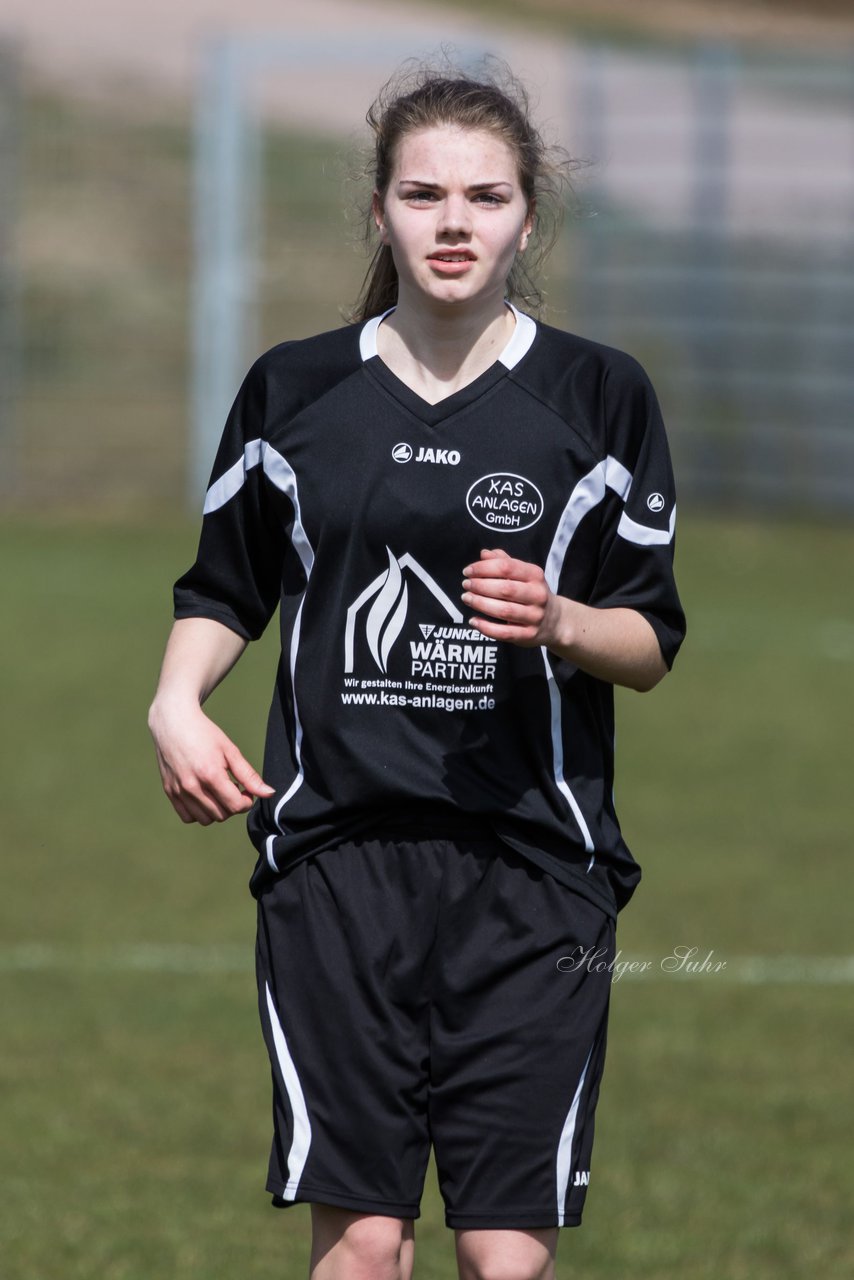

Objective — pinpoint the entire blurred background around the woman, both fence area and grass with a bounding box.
[0,0,854,1280]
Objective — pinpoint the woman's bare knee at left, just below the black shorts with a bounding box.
[311,1204,414,1280]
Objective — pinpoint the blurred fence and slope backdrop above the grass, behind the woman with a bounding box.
[0,0,854,515]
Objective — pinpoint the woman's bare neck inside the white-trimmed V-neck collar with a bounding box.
[376,297,516,404]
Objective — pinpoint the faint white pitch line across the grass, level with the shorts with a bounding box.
[0,942,854,986]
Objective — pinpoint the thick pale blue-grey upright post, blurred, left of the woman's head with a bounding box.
[188,40,250,507]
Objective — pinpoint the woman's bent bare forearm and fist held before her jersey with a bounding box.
[462,550,667,692]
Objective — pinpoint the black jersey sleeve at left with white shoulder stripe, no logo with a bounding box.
[174,360,287,640]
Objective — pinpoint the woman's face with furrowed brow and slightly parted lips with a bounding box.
[374,124,533,313]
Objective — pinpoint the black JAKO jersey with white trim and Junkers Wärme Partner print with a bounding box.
[175,304,685,913]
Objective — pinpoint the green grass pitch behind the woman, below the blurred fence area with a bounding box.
[0,516,854,1280]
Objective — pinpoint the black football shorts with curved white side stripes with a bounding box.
[257,829,615,1229]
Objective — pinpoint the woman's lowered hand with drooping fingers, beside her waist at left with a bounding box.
[149,699,274,827]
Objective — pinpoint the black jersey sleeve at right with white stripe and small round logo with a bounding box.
[589,358,685,667]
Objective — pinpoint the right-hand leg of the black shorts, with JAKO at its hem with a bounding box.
[429,846,615,1231]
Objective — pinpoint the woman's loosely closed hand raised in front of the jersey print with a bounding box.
[462,550,560,648]
